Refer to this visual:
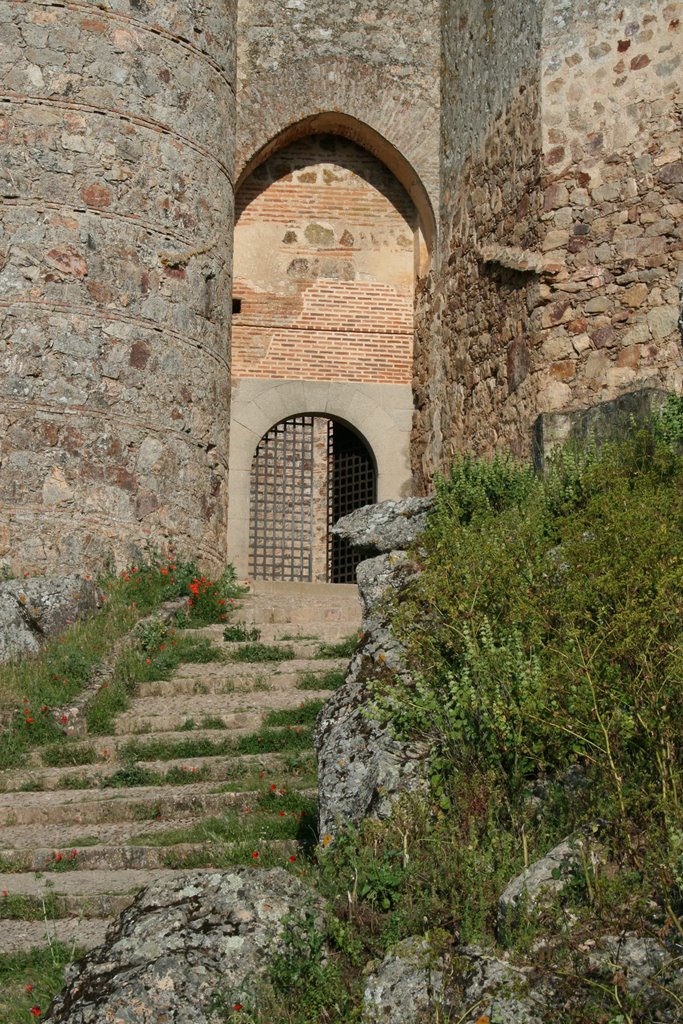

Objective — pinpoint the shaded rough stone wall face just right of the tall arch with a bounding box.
[413,0,541,490]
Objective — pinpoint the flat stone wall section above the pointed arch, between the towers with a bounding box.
[237,0,440,208]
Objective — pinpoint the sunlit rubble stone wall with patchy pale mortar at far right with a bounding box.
[532,0,683,412]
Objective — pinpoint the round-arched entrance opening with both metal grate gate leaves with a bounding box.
[249,416,377,583]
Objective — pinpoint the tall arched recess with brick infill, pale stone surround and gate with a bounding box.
[228,133,425,583]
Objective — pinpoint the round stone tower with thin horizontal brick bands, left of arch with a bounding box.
[0,0,237,570]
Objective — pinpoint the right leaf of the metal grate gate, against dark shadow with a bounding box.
[328,421,376,583]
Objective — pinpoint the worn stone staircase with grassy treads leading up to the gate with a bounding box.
[0,583,360,954]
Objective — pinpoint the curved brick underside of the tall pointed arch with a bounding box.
[236,111,436,258]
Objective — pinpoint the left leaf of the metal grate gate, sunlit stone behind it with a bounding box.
[249,416,313,582]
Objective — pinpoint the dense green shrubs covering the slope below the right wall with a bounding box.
[374,399,683,937]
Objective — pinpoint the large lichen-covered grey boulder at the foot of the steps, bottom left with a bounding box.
[47,867,322,1024]
